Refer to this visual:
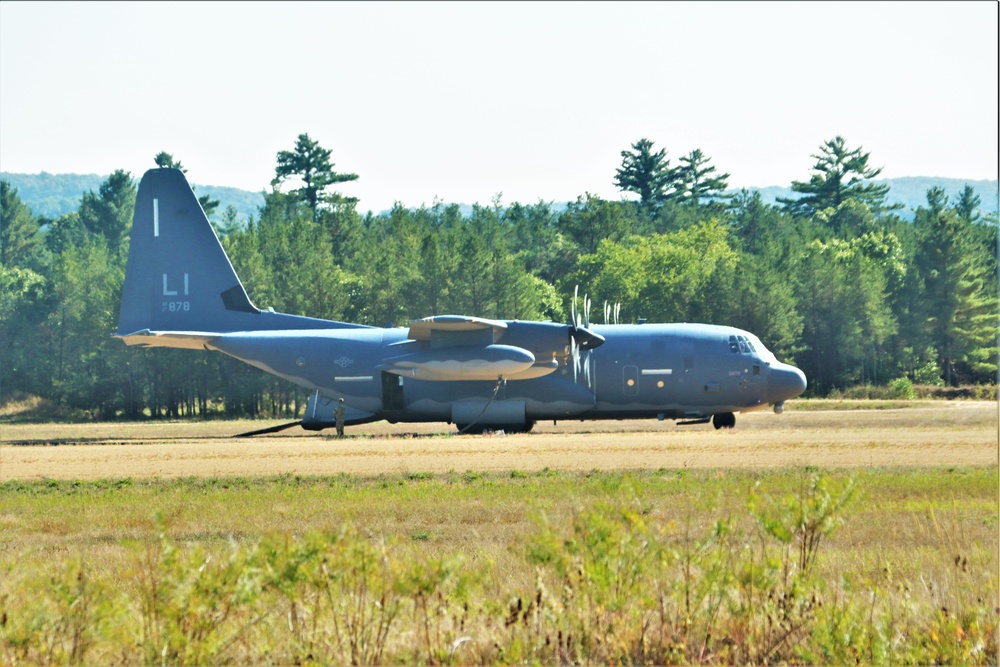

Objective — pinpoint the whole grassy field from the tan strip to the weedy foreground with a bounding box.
[0,403,1000,664]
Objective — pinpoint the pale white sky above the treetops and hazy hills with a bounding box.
[0,0,1000,211]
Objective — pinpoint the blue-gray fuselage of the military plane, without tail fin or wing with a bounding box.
[208,321,805,427]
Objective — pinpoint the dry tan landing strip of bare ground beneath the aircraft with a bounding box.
[0,403,1000,481]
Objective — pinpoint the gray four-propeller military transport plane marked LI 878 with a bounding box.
[116,168,806,431]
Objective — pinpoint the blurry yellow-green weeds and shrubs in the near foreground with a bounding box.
[0,474,998,665]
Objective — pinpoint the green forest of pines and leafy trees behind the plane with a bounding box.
[0,134,1000,419]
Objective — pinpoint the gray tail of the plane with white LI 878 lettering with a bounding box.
[117,169,355,348]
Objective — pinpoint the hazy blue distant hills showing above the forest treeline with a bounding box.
[0,171,1000,221]
